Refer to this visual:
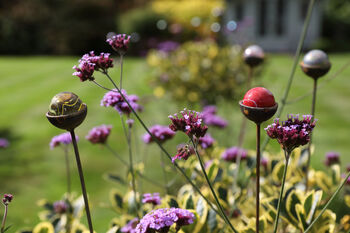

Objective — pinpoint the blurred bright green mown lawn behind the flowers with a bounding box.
[0,54,350,232]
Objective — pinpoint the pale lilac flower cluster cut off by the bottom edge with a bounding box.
[136,208,195,233]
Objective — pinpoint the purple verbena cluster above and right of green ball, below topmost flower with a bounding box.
[73,51,113,82]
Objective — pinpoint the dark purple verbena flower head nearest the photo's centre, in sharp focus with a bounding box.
[169,109,208,139]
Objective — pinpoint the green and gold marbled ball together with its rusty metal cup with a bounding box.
[46,92,87,131]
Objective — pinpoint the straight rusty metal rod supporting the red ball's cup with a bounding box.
[255,124,260,233]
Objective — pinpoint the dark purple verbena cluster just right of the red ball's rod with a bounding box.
[265,114,316,153]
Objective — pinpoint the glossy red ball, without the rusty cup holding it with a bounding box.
[243,87,276,108]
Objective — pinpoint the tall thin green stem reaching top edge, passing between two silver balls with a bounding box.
[261,0,316,151]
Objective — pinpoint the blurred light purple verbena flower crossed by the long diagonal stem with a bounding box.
[101,89,142,116]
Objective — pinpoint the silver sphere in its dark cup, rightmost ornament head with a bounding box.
[300,49,331,79]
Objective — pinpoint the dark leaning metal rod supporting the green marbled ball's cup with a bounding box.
[70,129,94,233]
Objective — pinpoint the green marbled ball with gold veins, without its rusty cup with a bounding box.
[49,92,84,116]
